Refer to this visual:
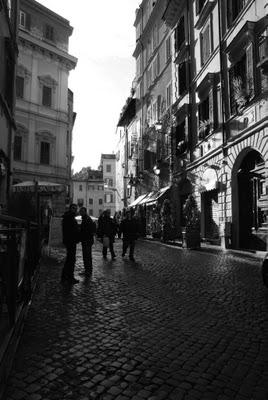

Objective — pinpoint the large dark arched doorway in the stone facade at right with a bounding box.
[232,148,268,250]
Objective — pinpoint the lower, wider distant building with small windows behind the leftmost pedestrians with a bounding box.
[72,170,104,218]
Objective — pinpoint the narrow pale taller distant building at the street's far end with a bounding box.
[100,154,116,215]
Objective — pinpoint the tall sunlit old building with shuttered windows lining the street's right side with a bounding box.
[126,0,268,250]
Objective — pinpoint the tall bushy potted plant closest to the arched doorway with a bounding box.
[183,194,201,249]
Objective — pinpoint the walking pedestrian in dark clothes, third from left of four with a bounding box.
[97,210,117,260]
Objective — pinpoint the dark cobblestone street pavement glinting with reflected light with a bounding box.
[4,241,268,400]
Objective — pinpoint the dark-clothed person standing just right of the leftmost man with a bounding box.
[79,207,96,276]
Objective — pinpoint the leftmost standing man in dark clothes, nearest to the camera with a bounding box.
[61,204,80,284]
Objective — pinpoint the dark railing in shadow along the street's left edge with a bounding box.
[0,215,40,332]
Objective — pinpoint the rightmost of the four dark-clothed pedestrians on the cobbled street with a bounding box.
[119,210,139,261]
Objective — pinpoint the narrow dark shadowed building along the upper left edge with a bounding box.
[0,0,18,212]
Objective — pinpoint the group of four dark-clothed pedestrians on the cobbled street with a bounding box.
[61,204,139,284]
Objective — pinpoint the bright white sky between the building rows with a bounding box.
[37,0,141,172]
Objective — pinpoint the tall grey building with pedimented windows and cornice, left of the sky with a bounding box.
[13,0,77,215]
